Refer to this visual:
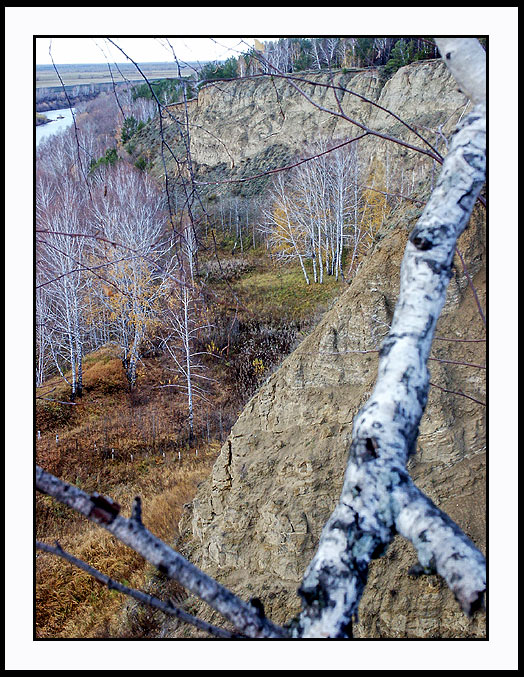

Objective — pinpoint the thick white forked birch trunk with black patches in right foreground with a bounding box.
[294,39,486,637]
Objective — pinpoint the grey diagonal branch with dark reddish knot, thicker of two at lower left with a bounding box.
[36,466,286,638]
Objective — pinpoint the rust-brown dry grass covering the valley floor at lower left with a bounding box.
[36,348,220,638]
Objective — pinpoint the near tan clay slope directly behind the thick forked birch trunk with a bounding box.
[177,203,485,637]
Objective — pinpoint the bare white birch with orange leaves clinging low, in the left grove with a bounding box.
[91,164,167,388]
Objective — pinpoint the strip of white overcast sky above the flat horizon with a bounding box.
[36,37,265,65]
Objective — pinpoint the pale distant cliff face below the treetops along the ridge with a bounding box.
[134,60,467,195]
